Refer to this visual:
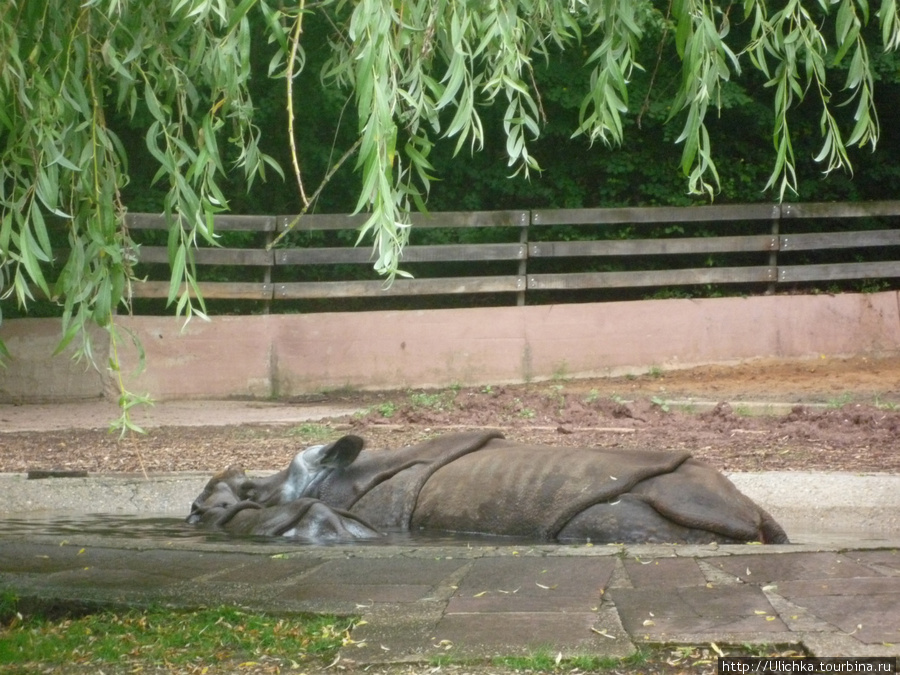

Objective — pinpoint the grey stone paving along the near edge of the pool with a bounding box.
[0,534,900,663]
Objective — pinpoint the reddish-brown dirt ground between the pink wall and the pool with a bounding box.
[0,356,900,473]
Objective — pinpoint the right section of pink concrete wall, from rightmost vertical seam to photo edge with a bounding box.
[526,292,900,377]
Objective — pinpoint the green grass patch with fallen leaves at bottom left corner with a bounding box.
[0,596,354,673]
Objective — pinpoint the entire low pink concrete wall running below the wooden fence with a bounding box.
[0,291,900,399]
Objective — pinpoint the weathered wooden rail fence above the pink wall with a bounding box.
[127,201,900,307]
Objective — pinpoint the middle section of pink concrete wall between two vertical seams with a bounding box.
[268,307,528,395]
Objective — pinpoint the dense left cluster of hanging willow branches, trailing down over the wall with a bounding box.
[0,0,280,428]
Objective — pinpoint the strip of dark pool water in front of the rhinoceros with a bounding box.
[0,513,536,546]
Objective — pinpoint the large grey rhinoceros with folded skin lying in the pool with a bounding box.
[188,432,788,544]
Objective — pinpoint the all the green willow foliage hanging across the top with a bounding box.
[0,0,900,422]
